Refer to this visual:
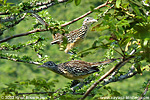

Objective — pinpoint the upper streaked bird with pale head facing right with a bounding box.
[51,17,97,53]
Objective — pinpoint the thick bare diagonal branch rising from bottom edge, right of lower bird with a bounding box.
[81,56,134,100]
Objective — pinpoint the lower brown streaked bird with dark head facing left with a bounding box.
[38,58,120,81]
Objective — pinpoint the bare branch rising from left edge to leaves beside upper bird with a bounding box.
[0,29,47,43]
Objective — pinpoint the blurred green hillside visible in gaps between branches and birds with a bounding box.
[0,0,149,96]
